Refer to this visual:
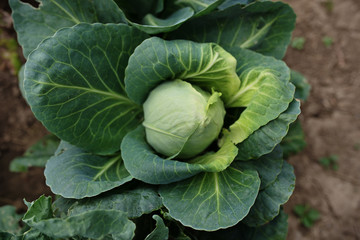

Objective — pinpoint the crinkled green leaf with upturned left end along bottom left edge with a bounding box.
[23,196,135,240]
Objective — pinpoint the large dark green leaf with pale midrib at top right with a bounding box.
[167,1,296,59]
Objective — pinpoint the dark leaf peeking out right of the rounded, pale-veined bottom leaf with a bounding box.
[243,162,295,227]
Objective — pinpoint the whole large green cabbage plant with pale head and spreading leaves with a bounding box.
[0,0,308,240]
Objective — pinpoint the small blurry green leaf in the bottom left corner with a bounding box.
[0,206,21,233]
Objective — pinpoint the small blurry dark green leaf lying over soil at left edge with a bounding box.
[10,135,60,172]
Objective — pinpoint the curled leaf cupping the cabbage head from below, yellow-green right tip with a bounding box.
[121,126,237,184]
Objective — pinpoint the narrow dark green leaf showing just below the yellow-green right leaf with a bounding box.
[236,100,300,161]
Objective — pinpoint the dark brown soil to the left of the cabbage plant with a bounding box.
[0,8,50,211]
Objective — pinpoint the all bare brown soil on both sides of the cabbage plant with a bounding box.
[0,0,360,240]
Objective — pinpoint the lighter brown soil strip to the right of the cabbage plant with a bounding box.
[285,0,360,240]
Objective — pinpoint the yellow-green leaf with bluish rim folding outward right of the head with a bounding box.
[225,47,295,144]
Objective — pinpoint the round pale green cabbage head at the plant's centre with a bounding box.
[143,80,225,159]
